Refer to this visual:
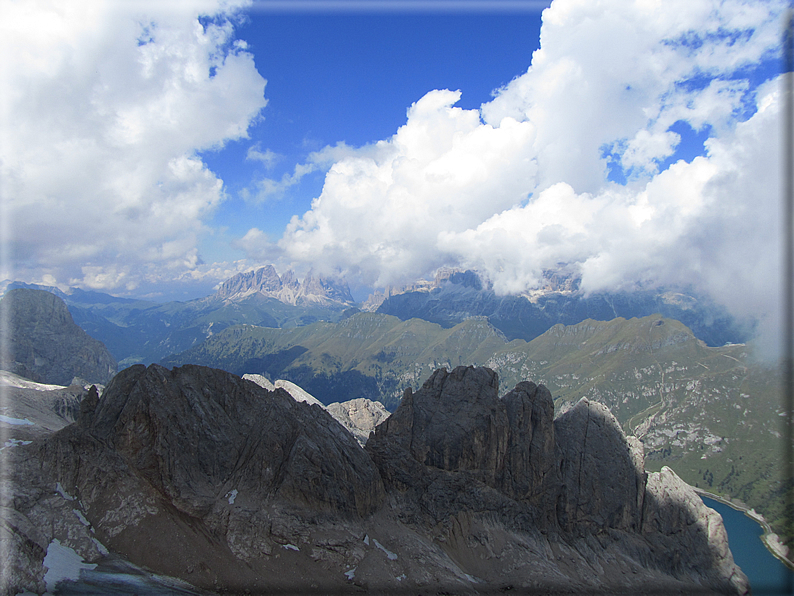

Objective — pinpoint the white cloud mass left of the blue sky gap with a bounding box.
[0,0,266,290]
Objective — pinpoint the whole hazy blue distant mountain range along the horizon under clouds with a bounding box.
[0,265,753,368]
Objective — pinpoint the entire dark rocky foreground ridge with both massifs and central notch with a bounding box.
[6,365,748,594]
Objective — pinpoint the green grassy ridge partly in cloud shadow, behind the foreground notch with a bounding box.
[162,313,507,408]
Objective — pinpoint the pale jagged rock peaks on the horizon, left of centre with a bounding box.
[212,265,353,305]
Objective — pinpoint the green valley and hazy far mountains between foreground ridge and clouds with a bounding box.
[3,267,794,588]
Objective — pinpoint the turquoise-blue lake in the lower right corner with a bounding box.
[702,497,794,596]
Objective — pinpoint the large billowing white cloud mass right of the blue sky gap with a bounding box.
[271,0,784,352]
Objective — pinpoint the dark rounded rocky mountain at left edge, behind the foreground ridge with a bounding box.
[0,288,117,385]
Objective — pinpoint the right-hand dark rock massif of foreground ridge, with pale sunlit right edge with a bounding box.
[365,367,747,593]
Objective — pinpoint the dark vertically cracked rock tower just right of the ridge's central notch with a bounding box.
[366,367,559,512]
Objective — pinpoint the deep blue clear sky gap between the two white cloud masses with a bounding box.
[201,3,548,260]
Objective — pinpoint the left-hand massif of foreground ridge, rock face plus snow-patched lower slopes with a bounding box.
[0,365,384,593]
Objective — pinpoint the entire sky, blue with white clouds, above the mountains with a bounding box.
[0,0,786,354]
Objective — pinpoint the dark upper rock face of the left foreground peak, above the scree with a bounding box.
[55,365,382,517]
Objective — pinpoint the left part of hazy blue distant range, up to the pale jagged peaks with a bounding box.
[0,266,353,368]
